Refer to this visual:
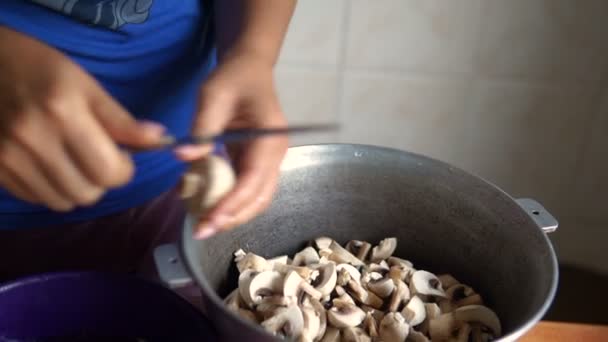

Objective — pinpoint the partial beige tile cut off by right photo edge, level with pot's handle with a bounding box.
[571,91,608,222]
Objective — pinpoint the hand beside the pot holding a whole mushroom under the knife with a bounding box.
[176,50,288,239]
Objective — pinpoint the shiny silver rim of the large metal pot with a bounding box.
[179,143,559,342]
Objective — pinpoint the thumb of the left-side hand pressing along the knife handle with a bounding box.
[91,88,170,147]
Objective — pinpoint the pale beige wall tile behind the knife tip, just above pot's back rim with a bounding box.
[341,73,469,166]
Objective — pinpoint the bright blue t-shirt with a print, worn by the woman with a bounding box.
[0,0,215,229]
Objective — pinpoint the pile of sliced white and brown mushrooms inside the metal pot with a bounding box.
[225,237,501,342]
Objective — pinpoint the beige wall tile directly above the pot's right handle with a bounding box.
[469,81,592,215]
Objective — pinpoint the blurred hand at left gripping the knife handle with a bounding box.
[0,27,163,211]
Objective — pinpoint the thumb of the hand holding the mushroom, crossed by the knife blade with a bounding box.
[175,90,234,161]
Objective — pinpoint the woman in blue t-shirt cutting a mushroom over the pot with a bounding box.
[0,0,295,279]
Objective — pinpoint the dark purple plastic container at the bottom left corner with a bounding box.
[0,272,217,342]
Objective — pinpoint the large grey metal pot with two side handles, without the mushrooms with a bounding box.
[156,144,558,341]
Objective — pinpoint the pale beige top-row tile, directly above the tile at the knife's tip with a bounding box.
[347,0,480,72]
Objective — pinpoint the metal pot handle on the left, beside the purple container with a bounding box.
[154,244,192,289]
